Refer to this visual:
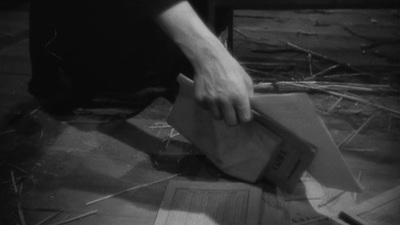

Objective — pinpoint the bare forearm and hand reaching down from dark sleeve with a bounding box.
[156,1,253,125]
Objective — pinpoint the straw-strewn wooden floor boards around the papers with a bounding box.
[0,4,400,225]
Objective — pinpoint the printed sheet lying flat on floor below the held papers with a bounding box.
[155,181,261,225]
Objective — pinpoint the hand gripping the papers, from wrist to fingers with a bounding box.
[194,52,253,126]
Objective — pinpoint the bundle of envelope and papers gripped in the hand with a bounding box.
[167,75,361,192]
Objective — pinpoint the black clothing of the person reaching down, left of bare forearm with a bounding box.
[29,0,227,110]
